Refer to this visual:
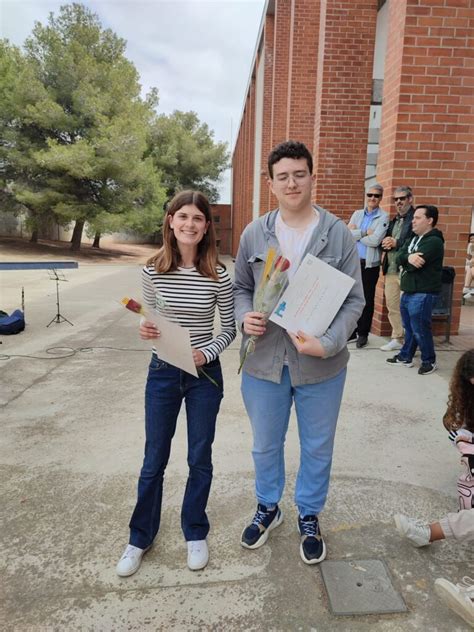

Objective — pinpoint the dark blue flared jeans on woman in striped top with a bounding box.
[130,355,223,549]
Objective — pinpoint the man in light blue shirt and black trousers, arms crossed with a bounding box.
[348,184,388,349]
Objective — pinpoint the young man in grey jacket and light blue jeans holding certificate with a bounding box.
[235,141,364,564]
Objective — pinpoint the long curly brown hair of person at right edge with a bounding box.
[443,349,474,432]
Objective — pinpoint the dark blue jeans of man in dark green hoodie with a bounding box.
[399,292,438,364]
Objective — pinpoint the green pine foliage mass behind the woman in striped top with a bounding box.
[0,3,229,248]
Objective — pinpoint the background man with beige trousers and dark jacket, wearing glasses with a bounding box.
[380,186,415,351]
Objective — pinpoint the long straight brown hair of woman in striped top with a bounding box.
[146,190,225,280]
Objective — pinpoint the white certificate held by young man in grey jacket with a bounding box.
[270,254,355,338]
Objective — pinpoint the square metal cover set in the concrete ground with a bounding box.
[320,560,407,615]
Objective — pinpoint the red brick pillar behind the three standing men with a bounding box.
[373,0,474,333]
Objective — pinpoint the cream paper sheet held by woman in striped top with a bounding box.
[144,311,198,377]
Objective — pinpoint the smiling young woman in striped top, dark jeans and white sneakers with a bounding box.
[117,191,236,577]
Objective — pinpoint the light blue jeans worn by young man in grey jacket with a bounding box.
[242,366,346,516]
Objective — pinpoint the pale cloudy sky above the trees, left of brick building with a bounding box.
[0,0,265,202]
